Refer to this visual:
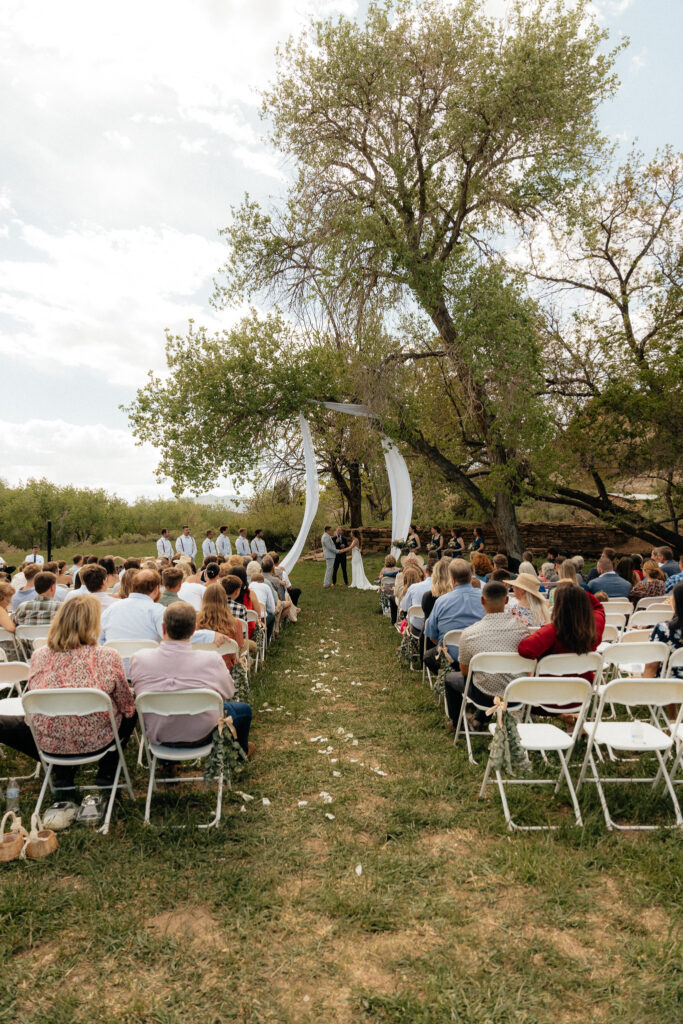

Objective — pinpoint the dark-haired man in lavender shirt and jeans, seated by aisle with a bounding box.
[130,601,254,755]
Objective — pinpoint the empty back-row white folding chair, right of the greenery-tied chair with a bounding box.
[577,679,683,831]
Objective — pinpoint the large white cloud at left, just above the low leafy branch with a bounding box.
[0,221,237,386]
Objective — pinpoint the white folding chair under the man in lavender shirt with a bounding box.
[135,690,229,828]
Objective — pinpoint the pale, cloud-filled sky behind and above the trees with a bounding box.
[0,0,683,500]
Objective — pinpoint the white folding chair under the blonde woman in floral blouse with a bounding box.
[22,686,135,836]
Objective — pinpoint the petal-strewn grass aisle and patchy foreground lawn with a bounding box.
[0,559,683,1024]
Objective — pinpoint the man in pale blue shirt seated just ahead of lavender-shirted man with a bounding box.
[99,569,219,675]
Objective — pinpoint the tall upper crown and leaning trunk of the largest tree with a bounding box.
[216,0,615,555]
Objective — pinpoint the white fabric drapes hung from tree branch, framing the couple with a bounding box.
[282,401,413,572]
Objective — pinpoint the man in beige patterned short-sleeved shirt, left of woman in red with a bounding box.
[445,583,528,728]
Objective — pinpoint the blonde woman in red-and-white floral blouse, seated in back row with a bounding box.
[0,594,136,790]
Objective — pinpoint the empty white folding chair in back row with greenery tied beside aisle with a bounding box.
[479,676,593,831]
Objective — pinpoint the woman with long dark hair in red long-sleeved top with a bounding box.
[517,582,605,683]
